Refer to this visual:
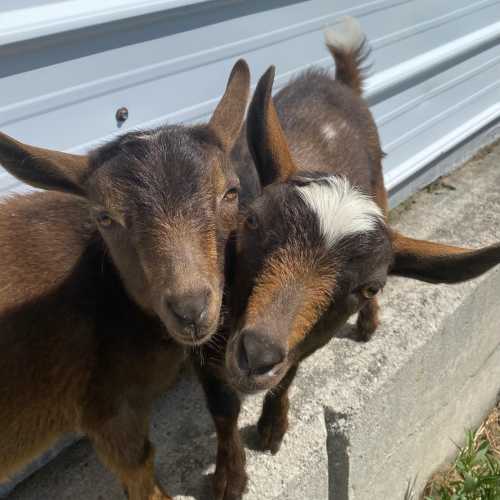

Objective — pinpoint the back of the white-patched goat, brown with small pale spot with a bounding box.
[274,69,384,209]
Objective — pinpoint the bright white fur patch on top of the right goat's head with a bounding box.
[296,175,383,248]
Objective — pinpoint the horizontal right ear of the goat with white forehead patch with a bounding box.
[390,232,500,283]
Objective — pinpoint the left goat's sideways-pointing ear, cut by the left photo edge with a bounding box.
[0,133,89,196]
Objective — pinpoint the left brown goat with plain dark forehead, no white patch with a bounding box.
[0,61,249,500]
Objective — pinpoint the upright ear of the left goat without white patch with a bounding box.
[209,59,250,152]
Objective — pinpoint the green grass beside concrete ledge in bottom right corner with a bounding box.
[423,406,500,500]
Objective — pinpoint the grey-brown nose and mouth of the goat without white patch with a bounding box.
[163,287,212,340]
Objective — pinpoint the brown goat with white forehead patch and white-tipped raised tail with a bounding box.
[196,18,500,500]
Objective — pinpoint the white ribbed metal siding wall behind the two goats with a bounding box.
[0,0,500,198]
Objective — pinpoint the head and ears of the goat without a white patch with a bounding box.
[0,61,249,345]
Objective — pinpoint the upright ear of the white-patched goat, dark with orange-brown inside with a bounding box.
[247,66,297,186]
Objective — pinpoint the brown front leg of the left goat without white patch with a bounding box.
[87,408,172,500]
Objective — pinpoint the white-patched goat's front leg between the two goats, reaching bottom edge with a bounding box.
[194,361,247,500]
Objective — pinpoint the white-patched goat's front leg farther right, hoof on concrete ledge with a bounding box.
[257,364,299,455]
